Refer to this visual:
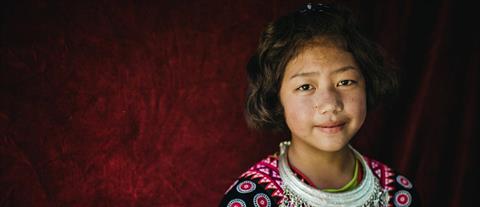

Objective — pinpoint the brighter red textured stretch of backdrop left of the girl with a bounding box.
[1,1,296,206]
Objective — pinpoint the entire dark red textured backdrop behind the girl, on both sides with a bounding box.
[0,0,480,206]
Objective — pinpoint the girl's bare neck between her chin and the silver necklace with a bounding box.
[288,140,355,189]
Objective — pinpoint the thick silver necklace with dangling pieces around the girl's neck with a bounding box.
[278,141,389,207]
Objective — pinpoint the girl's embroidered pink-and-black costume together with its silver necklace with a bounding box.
[220,142,419,207]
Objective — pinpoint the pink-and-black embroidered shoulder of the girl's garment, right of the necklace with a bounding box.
[364,157,420,207]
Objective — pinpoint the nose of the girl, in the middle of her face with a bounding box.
[314,88,343,114]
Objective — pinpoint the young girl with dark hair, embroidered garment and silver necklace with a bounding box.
[221,4,418,207]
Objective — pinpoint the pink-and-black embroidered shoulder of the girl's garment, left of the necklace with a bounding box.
[220,156,283,207]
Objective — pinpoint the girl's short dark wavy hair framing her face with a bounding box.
[245,4,398,132]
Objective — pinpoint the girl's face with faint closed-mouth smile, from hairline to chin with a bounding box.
[280,45,367,152]
